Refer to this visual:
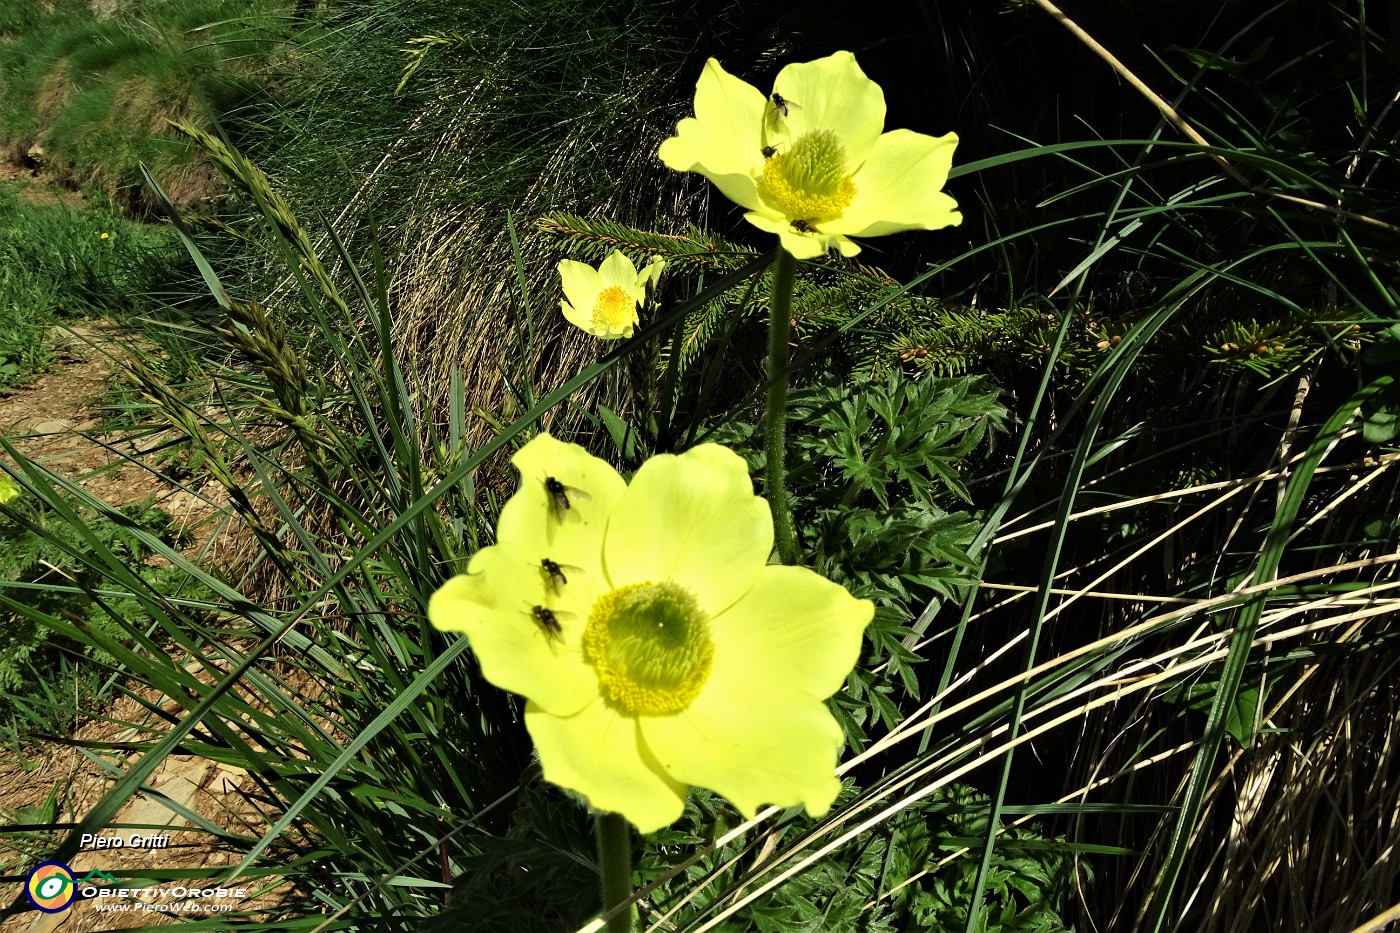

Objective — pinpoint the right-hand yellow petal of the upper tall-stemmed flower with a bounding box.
[825,130,962,237]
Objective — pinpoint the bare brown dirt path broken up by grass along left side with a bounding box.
[0,322,284,933]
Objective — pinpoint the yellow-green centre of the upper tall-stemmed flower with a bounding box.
[759,130,855,226]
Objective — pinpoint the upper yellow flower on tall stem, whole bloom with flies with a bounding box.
[658,52,962,259]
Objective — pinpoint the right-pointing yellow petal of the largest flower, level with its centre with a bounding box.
[706,565,875,699]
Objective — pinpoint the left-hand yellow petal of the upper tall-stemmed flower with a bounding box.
[657,59,767,210]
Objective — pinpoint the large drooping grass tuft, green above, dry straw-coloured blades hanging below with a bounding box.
[238,0,767,453]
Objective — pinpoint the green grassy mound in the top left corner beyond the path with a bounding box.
[0,0,293,212]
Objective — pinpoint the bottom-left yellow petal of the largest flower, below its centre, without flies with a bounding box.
[525,698,687,832]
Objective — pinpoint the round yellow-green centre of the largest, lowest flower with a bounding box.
[584,581,714,716]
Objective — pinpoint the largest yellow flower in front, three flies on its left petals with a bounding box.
[428,434,875,832]
